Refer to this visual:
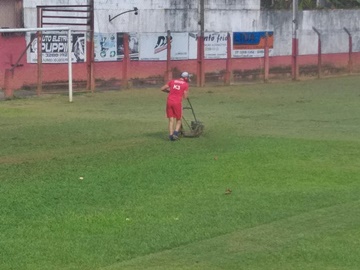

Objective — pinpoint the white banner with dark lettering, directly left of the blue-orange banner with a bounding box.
[189,32,227,59]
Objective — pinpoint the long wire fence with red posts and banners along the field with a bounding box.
[0,0,360,99]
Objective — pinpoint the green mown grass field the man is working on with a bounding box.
[0,77,360,270]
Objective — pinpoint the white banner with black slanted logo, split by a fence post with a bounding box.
[139,33,189,60]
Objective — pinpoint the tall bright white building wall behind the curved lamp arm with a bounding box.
[24,0,260,33]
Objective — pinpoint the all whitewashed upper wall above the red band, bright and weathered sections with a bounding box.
[24,0,360,56]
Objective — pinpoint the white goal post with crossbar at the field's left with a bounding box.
[0,27,73,102]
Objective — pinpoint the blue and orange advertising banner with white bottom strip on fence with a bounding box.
[232,31,274,58]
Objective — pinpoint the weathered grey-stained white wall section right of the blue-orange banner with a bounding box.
[260,10,360,56]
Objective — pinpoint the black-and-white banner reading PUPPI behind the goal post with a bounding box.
[26,32,86,64]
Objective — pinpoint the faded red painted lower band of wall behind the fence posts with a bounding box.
[0,36,360,92]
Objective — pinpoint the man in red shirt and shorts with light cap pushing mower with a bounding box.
[161,71,189,141]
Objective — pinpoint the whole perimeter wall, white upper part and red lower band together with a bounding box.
[0,0,360,92]
